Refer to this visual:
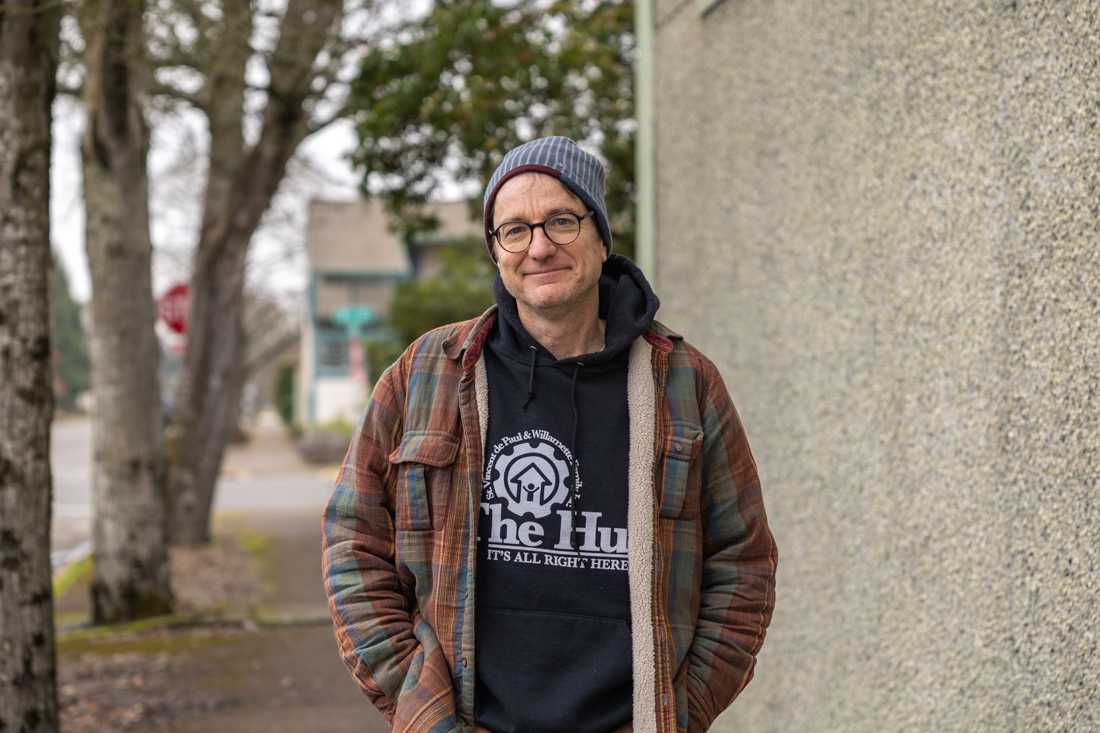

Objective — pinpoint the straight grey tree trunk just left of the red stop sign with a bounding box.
[81,0,173,623]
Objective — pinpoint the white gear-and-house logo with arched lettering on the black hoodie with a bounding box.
[485,430,581,519]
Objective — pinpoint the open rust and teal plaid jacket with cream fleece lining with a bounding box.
[322,307,778,733]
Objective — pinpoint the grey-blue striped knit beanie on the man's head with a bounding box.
[483,136,612,258]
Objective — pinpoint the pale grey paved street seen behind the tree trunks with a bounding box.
[51,419,332,561]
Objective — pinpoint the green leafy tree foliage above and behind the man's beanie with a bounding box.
[350,0,636,255]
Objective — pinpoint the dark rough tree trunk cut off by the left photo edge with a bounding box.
[0,0,58,733]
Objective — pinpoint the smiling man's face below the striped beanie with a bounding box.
[493,173,607,310]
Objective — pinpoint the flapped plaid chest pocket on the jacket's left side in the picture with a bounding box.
[389,430,459,529]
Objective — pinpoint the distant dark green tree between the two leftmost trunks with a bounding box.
[50,255,91,409]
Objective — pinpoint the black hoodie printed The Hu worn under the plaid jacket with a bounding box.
[475,255,659,733]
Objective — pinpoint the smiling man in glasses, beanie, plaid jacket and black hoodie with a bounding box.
[323,138,777,733]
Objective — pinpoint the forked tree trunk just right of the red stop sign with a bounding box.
[168,0,343,545]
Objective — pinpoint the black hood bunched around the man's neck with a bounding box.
[491,254,661,369]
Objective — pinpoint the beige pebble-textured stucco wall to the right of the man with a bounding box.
[655,0,1100,732]
